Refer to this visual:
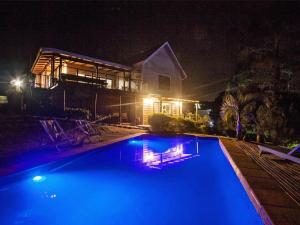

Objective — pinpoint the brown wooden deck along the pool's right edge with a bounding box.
[220,138,300,225]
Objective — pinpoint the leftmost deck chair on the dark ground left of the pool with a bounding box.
[40,119,78,150]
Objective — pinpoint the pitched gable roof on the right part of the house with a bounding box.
[133,42,187,80]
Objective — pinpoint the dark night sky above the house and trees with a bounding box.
[0,2,300,100]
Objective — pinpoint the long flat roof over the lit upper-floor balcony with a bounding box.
[31,48,132,74]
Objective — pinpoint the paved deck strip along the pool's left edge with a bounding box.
[0,127,144,176]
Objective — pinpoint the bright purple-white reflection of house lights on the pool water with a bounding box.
[120,140,199,168]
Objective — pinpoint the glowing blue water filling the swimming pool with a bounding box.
[0,135,262,225]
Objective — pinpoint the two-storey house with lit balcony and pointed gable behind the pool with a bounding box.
[31,42,197,124]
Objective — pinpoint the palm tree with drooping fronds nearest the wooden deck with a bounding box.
[220,86,259,139]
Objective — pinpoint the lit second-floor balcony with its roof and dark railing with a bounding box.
[31,48,141,92]
